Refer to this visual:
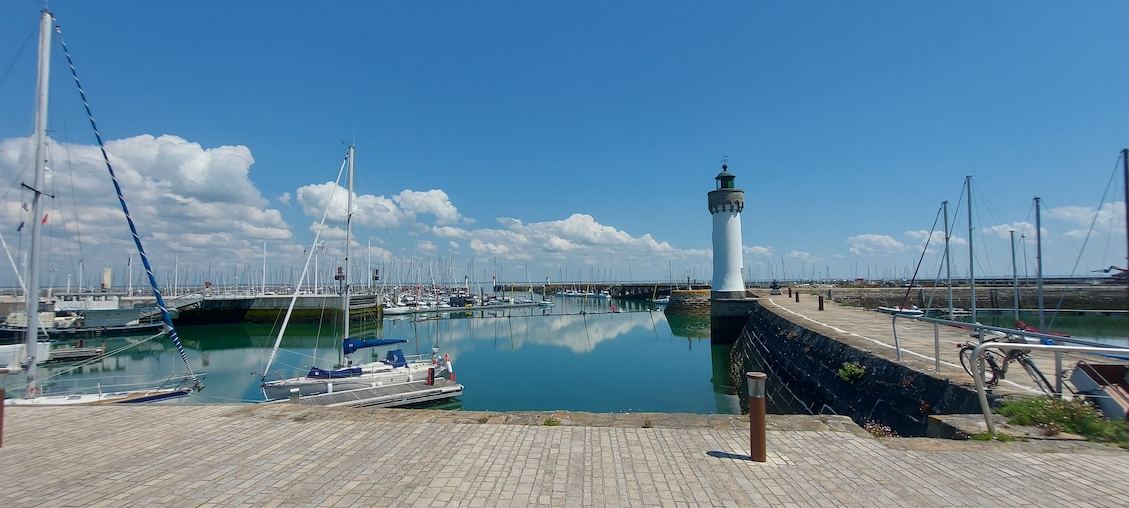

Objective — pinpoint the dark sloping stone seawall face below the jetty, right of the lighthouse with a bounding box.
[730,305,980,436]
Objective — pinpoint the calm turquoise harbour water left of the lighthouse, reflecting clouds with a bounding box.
[6,297,739,413]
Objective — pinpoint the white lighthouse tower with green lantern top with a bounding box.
[709,164,745,299]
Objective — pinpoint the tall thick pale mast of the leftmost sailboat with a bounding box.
[24,10,52,398]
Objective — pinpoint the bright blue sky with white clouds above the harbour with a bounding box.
[0,0,1129,291]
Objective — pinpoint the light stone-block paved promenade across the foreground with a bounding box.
[0,404,1129,508]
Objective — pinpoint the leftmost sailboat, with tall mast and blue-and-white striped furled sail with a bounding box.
[5,10,203,405]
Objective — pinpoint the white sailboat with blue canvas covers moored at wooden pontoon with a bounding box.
[261,144,454,401]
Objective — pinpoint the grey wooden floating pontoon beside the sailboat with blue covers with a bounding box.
[271,377,463,408]
